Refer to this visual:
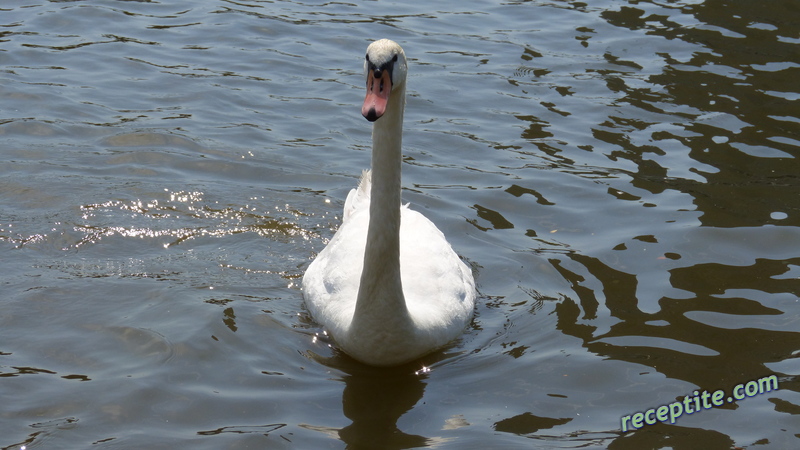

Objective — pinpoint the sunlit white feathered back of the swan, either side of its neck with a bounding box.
[303,171,475,364]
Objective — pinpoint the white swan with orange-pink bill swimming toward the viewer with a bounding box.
[302,39,476,366]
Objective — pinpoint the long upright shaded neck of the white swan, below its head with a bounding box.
[353,85,411,330]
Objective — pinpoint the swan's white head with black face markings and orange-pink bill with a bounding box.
[361,39,408,122]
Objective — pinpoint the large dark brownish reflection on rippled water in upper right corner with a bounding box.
[601,1,800,227]
